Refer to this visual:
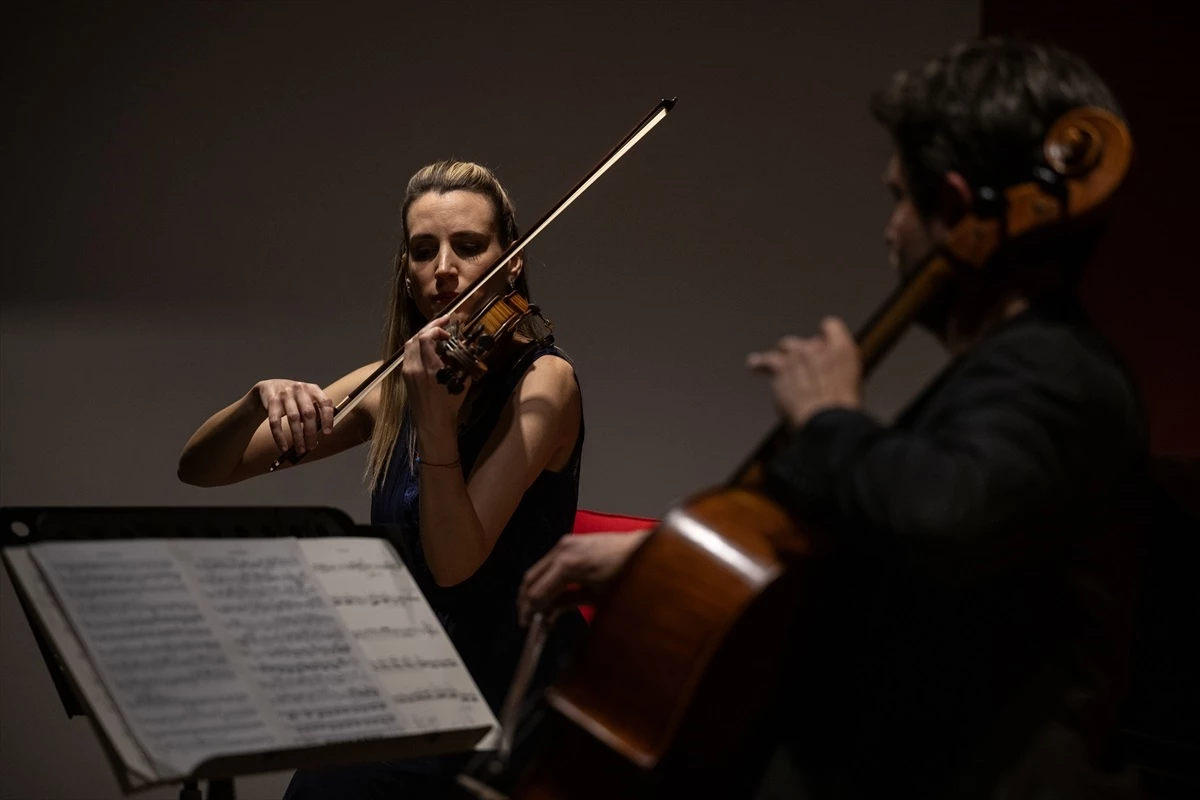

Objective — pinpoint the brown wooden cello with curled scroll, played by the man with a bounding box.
[470,108,1132,800]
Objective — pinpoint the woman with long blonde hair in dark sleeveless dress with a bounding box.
[179,162,583,800]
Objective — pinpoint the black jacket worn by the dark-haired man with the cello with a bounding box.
[767,299,1147,800]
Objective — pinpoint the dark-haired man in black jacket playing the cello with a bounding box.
[520,40,1147,800]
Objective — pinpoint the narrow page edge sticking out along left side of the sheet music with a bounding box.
[5,547,155,788]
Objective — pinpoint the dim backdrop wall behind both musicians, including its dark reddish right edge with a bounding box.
[28,0,1200,798]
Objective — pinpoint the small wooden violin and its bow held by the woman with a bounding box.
[268,97,677,473]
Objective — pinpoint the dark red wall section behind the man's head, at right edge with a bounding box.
[982,0,1200,460]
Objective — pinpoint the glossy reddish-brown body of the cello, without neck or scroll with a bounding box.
[516,488,815,800]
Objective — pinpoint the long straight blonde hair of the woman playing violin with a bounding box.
[366,161,540,491]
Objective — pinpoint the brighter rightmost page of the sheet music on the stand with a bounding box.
[299,537,498,746]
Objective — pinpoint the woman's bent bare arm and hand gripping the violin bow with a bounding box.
[178,362,379,486]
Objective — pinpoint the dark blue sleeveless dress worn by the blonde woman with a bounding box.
[290,345,586,800]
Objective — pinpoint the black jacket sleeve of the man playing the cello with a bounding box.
[767,329,1138,551]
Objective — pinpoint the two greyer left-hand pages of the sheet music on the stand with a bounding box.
[31,539,412,776]
